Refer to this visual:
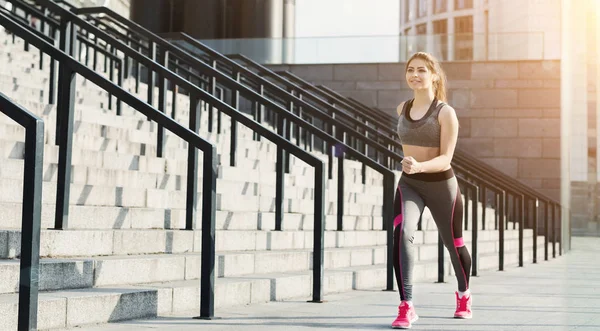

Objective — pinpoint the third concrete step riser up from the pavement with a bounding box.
[0,229,533,259]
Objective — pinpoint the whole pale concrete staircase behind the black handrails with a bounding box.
[0,32,544,330]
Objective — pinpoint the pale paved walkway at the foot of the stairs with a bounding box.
[67,238,600,331]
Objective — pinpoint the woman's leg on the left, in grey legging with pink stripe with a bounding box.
[394,179,425,301]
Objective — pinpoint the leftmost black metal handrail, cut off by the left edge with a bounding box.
[0,93,44,330]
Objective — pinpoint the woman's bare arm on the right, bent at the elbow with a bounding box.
[417,105,458,173]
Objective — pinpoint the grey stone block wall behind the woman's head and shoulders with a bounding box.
[271,61,560,200]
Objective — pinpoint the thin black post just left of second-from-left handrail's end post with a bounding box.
[185,94,202,230]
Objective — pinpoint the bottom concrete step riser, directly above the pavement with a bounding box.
[0,240,556,330]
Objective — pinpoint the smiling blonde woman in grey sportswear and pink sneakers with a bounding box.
[392,53,472,329]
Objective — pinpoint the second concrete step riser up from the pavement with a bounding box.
[0,237,543,293]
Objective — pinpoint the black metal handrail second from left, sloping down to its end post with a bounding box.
[0,9,223,322]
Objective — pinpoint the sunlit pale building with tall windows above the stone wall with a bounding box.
[400,0,560,61]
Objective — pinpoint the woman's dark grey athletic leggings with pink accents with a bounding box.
[394,169,471,301]
